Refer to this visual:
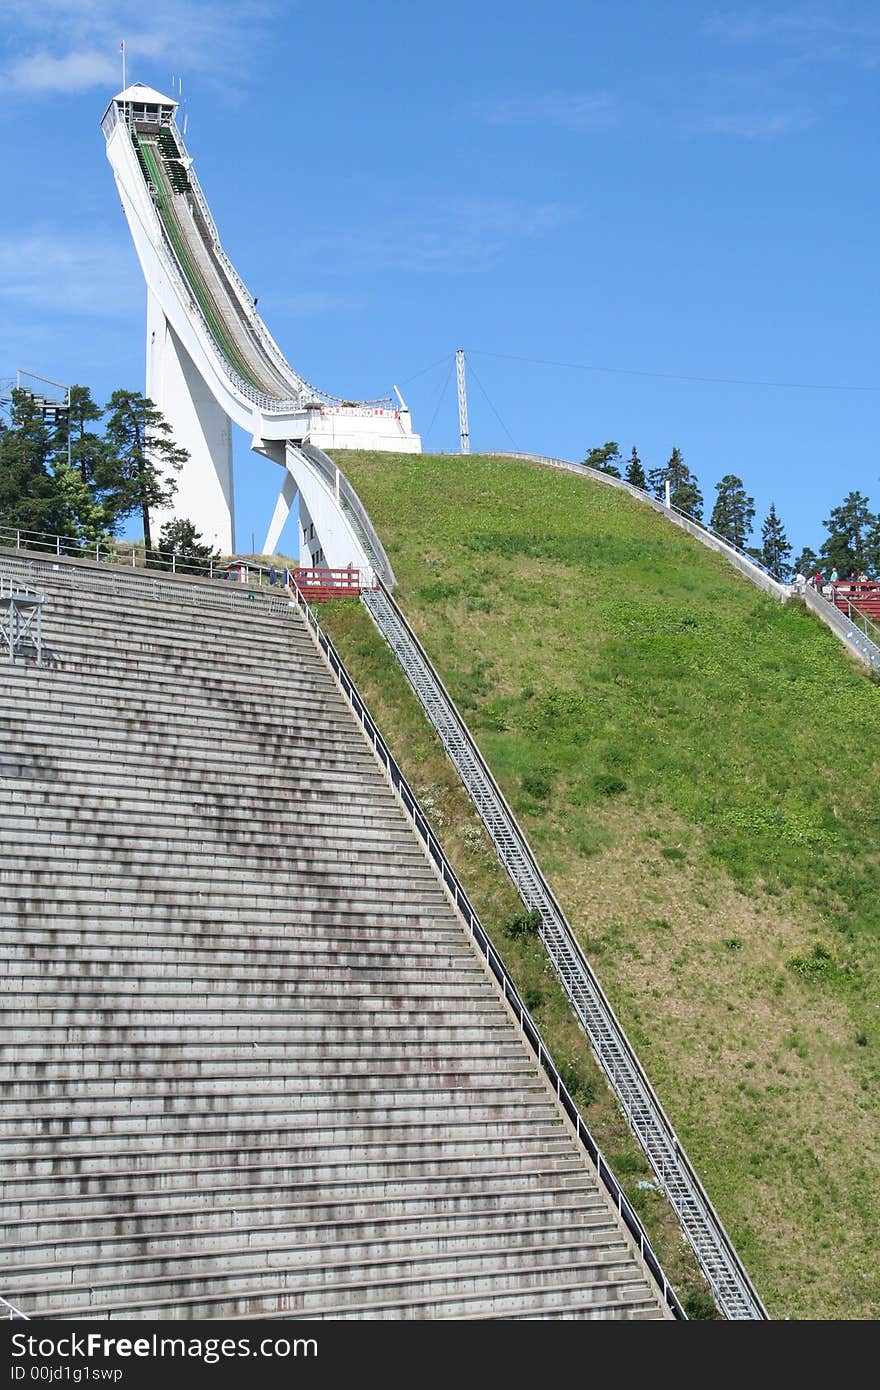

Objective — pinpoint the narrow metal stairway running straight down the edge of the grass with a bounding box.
[361,580,767,1319]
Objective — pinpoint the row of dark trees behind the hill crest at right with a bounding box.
[575,439,880,581]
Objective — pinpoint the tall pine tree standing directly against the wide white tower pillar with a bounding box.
[96,391,189,553]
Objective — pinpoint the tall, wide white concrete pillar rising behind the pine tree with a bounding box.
[146,289,235,555]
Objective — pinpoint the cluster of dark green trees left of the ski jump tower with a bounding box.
[0,386,217,566]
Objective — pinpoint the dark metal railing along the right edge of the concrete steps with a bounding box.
[284,575,687,1321]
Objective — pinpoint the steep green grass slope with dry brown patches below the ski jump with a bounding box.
[328,452,880,1318]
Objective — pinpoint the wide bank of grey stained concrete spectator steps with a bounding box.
[0,553,678,1319]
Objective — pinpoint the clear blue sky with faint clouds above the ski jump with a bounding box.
[0,0,880,549]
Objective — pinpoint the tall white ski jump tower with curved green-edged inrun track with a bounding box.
[101,82,421,558]
